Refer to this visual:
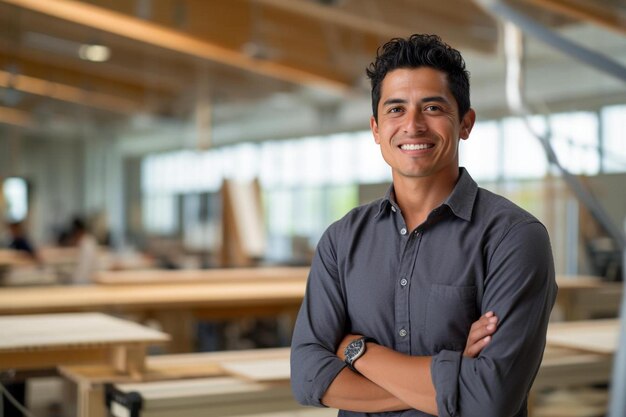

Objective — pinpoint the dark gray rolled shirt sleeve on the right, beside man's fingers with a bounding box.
[431,220,557,417]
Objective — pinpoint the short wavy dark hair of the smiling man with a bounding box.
[365,34,470,121]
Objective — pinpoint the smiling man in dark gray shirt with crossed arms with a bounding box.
[291,35,557,417]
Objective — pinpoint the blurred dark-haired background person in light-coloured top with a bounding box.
[70,217,98,284]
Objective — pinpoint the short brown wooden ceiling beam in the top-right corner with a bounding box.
[526,0,626,35]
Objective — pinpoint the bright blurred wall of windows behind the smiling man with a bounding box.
[142,105,626,257]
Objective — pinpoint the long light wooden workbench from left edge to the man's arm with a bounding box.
[0,268,306,352]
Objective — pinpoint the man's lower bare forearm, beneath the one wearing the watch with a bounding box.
[322,368,411,413]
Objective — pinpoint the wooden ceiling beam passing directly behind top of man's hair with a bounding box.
[252,0,496,52]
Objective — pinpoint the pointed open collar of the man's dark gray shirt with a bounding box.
[374,167,478,221]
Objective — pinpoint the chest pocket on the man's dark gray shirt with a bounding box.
[425,284,479,353]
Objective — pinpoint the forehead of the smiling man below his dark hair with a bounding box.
[380,67,452,98]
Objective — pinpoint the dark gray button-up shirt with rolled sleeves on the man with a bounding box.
[291,168,557,417]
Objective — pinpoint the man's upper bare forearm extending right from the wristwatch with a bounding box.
[355,343,437,415]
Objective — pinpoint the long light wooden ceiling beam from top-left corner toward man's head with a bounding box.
[0,0,350,93]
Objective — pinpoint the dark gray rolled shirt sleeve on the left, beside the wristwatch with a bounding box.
[291,226,346,407]
